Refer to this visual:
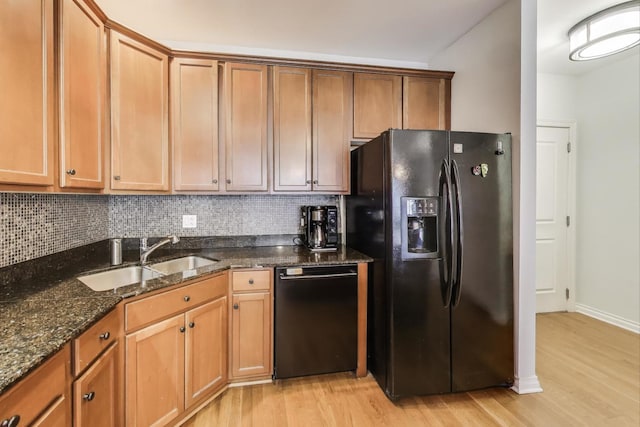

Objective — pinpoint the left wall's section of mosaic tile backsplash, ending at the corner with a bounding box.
[0,193,109,267]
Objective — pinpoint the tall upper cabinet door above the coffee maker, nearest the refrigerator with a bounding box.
[313,70,353,193]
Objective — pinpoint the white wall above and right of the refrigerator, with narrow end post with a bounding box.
[429,0,541,393]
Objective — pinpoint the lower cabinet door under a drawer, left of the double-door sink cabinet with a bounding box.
[73,342,118,427]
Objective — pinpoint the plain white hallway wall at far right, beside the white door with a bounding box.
[576,55,640,330]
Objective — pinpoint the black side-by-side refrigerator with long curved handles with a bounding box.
[345,129,514,400]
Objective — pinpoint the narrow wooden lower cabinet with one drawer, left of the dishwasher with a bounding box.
[229,269,273,380]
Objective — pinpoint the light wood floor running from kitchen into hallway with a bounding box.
[185,313,640,427]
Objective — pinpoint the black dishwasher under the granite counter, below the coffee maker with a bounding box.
[273,265,358,378]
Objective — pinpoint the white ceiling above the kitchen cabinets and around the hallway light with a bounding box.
[96,0,640,74]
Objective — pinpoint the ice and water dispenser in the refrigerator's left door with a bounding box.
[401,197,439,259]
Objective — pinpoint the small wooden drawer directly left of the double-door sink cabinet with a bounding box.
[73,307,122,377]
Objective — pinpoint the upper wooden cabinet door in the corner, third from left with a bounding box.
[110,31,169,191]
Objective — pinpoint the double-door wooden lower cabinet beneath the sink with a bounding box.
[125,273,228,427]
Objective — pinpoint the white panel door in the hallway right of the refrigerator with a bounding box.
[536,126,573,313]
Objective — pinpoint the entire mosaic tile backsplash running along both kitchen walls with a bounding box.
[0,193,339,268]
